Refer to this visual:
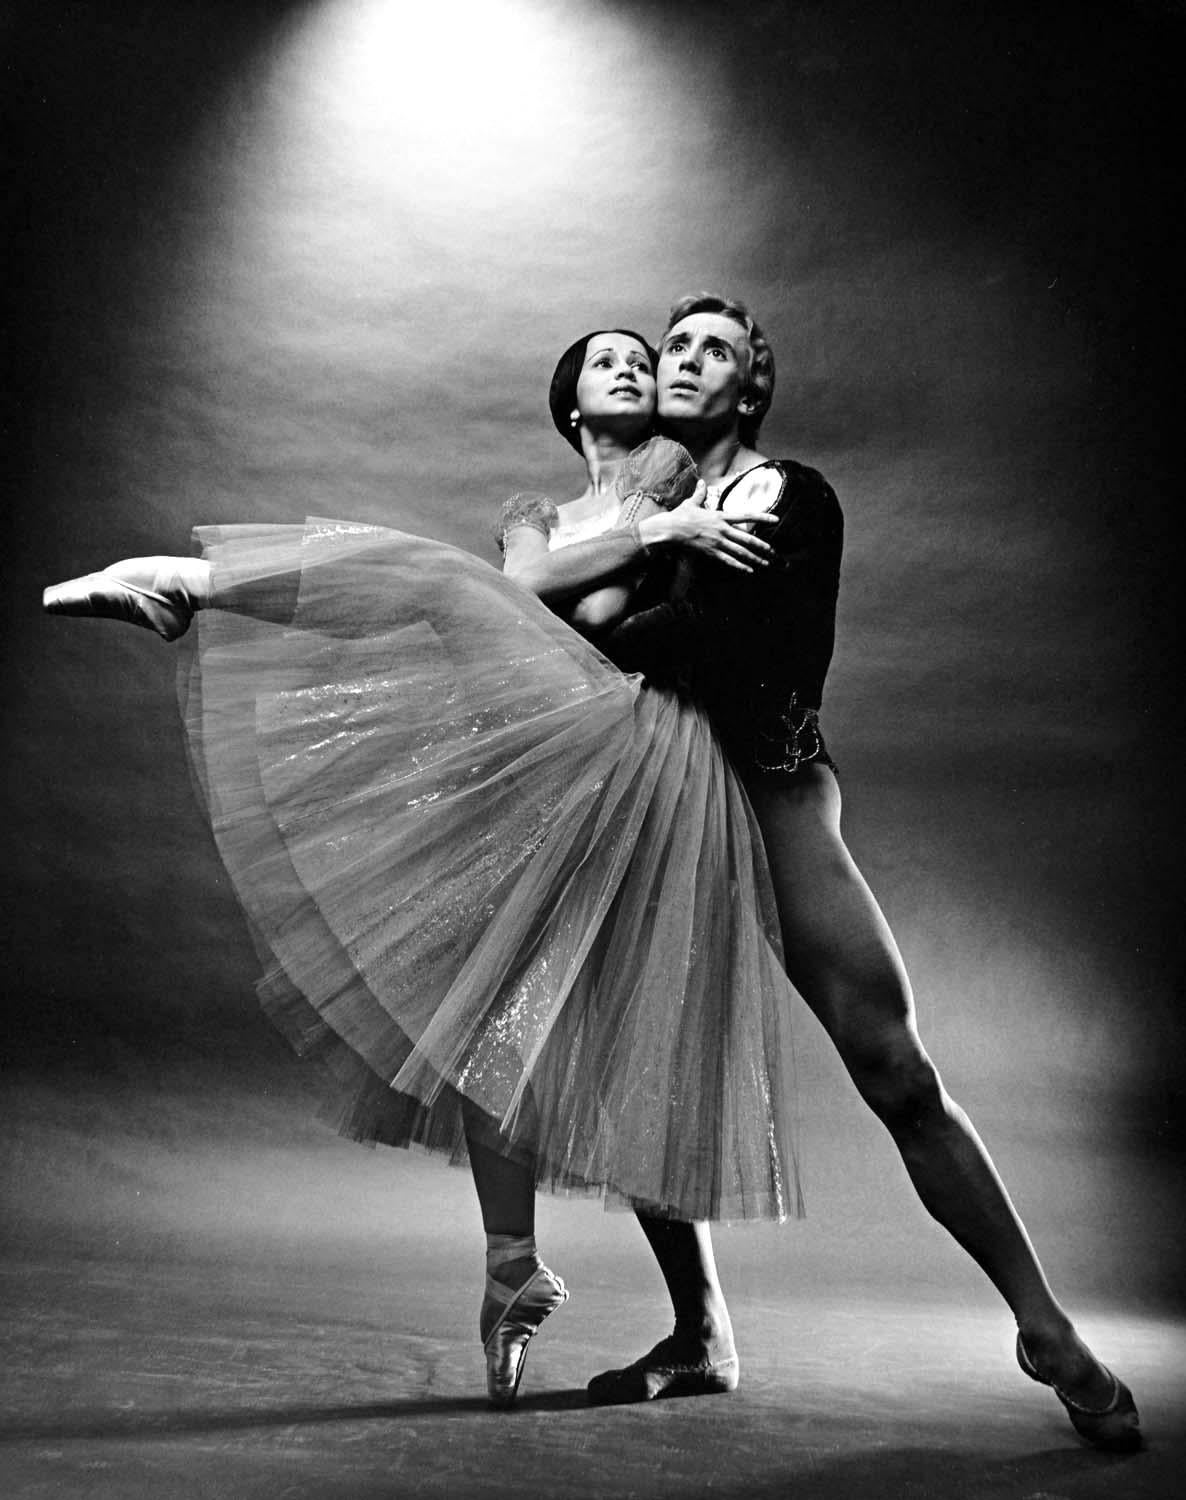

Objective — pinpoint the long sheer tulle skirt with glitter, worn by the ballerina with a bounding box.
[183,521,799,1220]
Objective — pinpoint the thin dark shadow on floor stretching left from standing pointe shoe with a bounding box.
[0,1388,591,1445]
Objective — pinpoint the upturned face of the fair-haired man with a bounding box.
[657,312,750,435]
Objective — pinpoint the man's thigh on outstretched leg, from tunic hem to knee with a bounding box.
[747,764,918,1067]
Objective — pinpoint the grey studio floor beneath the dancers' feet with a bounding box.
[0,1169,1186,1500]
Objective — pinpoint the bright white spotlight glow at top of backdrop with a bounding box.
[171,0,731,480]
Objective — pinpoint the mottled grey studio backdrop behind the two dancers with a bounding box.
[0,0,1183,1304]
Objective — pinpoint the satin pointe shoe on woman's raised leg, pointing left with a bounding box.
[42,557,210,641]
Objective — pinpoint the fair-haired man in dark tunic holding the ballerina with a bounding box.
[589,286,1140,1448]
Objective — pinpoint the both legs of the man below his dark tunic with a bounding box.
[591,767,1135,1442]
